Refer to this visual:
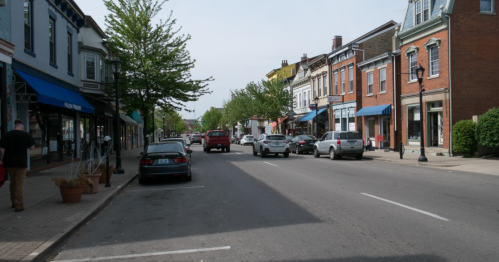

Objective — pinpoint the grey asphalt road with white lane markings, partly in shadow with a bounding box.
[55,138,499,262]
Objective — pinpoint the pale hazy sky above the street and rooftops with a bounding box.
[75,0,407,119]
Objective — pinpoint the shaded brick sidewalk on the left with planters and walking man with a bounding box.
[0,148,142,262]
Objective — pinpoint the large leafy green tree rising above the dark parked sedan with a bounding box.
[104,0,213,148]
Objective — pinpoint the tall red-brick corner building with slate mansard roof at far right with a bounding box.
[397,0,499,154]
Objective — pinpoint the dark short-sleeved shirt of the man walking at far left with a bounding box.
[0,130,35,168]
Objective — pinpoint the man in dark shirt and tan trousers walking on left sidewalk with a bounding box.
[0,120,35,212]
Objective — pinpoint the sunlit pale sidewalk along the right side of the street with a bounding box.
[364,151,499,175]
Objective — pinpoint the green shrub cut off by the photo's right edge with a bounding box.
[475,108,499,148]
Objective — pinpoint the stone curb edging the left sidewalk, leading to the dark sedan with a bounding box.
[21,175,138,262]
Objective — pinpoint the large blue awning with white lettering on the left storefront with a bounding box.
[15,70,94,114]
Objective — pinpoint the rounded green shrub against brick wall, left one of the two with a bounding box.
[452,120,477,155]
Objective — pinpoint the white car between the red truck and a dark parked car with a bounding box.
[253,134,289,158]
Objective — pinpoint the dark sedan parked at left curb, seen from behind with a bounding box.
[139,141,192,184]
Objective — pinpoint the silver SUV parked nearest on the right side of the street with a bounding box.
[314,131,364,160]
